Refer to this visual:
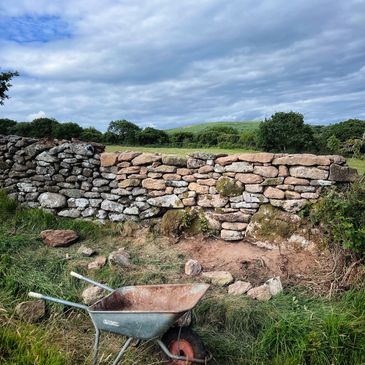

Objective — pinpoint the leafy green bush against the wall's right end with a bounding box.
[310,177,365,256]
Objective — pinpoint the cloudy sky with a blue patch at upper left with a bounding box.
[0,0,365,131]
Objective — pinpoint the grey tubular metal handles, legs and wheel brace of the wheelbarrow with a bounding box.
[28,271,212,365]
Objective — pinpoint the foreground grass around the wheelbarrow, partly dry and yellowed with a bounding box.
[0,191,365,365]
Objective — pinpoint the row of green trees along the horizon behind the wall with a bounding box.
[0,112,365,157]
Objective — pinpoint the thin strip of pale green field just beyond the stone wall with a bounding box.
[106,146,365,175]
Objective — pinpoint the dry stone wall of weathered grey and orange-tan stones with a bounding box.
[0,136,357,240]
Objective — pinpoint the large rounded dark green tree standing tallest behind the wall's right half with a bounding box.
[258,112,315,152]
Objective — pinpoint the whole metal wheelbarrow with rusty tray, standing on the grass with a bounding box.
[28,272,211,365]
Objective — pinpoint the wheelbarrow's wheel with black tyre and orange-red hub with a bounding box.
[162,327,207,365]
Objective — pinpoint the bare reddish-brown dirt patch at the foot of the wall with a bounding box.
[176,237,332,286]
